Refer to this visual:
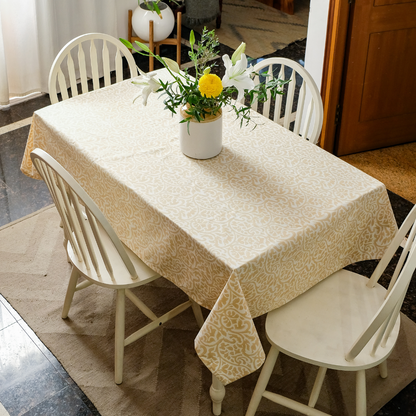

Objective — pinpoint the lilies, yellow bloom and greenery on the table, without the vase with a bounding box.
[120,28,288,127]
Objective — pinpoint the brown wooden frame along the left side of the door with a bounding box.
[320,0,352,153]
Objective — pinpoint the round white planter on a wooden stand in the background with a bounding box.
[131,2,175,42]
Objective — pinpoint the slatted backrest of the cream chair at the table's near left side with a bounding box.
[30,149,138,279]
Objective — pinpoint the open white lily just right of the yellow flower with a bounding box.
[222,53,254,101]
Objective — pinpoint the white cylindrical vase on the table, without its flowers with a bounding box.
[179,107,222,159]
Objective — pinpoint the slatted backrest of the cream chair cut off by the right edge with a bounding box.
[345,206,416,361]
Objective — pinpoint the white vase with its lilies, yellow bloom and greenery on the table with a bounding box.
[120,28,288,159]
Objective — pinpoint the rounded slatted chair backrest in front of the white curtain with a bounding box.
[49,33,137,104]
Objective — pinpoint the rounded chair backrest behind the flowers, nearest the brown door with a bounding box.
[252,58,324,144]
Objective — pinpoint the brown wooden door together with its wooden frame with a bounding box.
[321,0,416,156]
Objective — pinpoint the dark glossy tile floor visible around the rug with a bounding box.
[0,34,416,416]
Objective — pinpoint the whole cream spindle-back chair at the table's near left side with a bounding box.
[31,149,203,384]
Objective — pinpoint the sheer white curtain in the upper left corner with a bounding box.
[0,0,117,105]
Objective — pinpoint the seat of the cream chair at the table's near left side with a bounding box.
[67,219,160,289]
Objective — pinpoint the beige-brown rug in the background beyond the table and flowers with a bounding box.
[188,0,310,58]
